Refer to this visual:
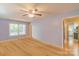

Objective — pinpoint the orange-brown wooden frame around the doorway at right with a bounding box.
[63,17,79,51]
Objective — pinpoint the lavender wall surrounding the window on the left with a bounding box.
[0,19,28,40]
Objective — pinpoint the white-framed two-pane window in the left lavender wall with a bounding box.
[9,23,26,36]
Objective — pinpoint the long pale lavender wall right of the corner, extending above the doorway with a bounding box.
[32,9,79,47]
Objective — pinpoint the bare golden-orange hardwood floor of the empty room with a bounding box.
[0,38,65,56]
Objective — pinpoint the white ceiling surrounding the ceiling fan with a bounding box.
[0,3,79,22]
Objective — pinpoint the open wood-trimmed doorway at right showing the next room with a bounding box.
[63,17,79,55]
